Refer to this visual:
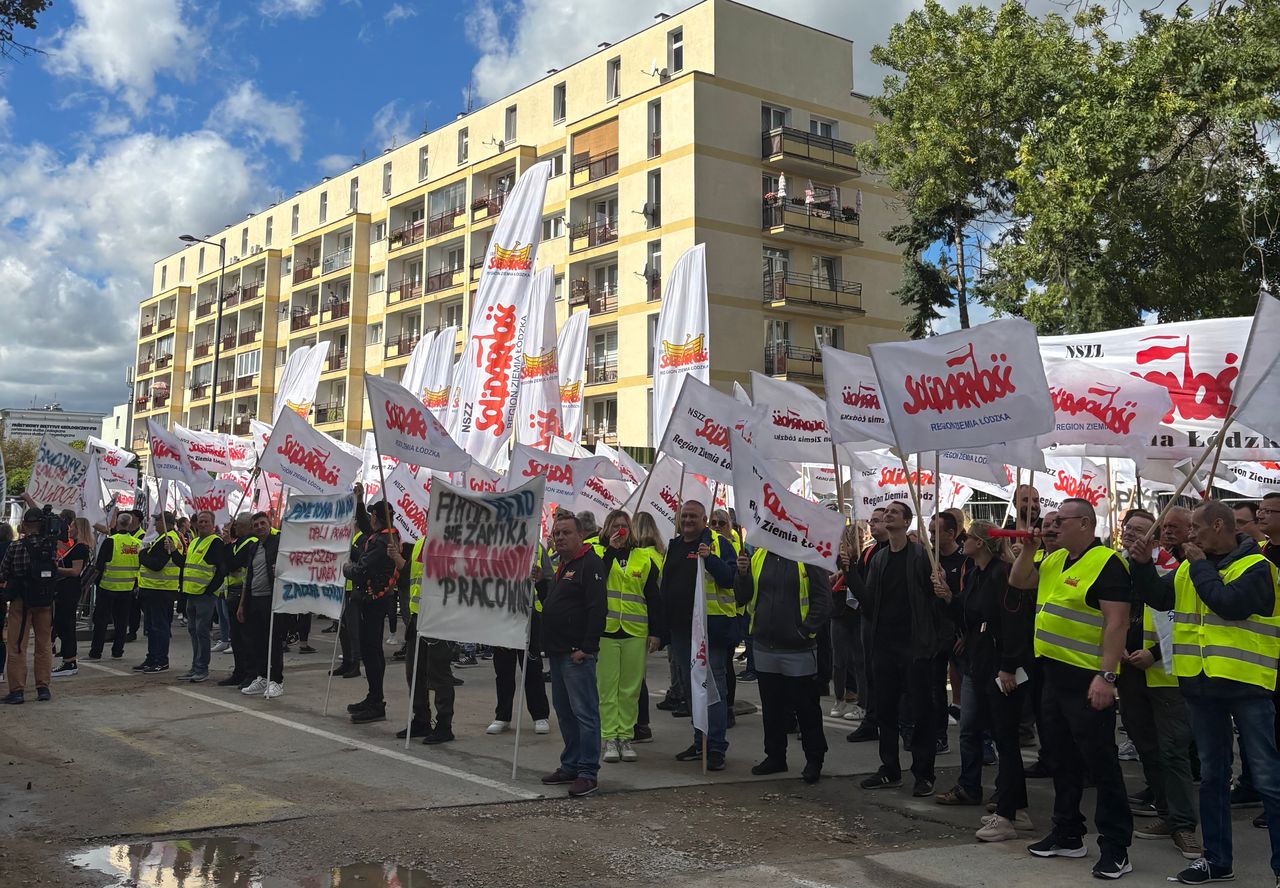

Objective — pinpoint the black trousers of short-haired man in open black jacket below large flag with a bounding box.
[872,645,938,781]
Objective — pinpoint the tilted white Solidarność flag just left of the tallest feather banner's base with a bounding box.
[365,374,471,472]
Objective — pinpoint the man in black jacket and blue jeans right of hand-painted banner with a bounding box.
[541,513,609,798]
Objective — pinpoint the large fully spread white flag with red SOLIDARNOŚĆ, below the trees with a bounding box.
[870,319,1053,453]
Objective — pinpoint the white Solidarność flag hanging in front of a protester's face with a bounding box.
[733,435,845,571]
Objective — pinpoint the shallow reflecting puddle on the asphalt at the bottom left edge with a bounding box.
[70,838,442,888]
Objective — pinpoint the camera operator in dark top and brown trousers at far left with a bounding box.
[0,509,67,704]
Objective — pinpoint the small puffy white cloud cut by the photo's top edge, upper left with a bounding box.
[47,0,205,115]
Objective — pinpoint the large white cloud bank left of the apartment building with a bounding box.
[0,131,269,411]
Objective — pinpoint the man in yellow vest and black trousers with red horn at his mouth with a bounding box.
[1009,499,1133,879]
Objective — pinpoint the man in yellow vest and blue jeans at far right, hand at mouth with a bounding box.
[1129,500,1280,885]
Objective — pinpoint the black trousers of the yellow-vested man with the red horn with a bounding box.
[1041,662,1133,855]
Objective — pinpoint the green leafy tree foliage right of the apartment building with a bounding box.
[860,0,1280,333]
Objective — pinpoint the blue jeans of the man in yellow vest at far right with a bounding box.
[1187,695,1280,874]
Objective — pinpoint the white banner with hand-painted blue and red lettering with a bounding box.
[271,493,356,619]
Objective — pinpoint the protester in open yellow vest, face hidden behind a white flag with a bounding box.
[733,548,831,783]
